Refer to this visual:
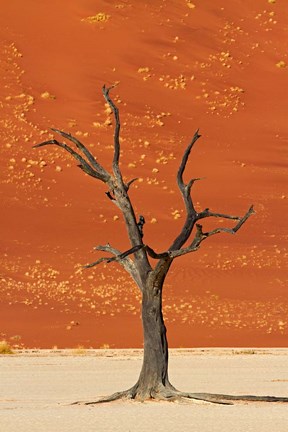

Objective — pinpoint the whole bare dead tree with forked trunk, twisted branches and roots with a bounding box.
[35,86,288,404]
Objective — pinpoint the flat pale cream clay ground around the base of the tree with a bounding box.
[0,349,288,432]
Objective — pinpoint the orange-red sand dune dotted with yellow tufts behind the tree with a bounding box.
[0,0,288,348]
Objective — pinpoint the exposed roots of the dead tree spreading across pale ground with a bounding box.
[71,386,288,405]
